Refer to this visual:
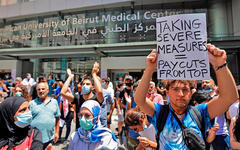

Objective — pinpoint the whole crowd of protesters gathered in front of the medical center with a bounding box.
[0,45,240,150]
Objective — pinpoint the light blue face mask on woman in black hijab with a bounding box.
[14,111,32,128]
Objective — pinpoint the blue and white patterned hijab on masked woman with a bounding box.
[77,100,117,143]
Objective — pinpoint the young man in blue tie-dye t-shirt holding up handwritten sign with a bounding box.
[135,44,238,149]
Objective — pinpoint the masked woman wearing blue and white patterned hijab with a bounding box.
[68,100,118,150]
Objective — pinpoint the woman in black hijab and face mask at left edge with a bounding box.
[0,96,43,150]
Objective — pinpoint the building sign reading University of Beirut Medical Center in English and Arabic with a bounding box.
[0,9,206,48]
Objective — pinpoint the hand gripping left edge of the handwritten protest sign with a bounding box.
[146,49,158,71]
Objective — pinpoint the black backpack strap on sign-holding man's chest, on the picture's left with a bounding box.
[156,105,169,150]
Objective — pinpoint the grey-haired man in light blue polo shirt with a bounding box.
[29,82,61,149]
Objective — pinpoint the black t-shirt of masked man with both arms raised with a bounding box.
[72,92,99,129]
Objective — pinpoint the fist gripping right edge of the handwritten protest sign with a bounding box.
[207,44,227,69]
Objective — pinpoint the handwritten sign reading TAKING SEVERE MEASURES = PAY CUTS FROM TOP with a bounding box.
[156,13,210,80]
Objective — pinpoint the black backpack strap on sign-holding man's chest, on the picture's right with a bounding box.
[189,106,206,141]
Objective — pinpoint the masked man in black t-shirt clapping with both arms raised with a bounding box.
[61,62,104,129]
